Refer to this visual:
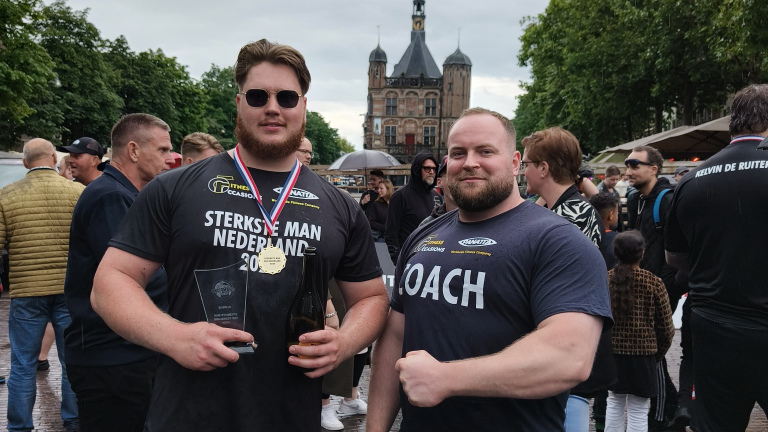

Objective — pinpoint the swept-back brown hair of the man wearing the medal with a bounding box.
[233,39,312,96]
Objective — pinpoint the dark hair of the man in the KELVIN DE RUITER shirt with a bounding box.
[728,84,768,136]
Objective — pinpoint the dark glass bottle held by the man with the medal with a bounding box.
[285,246,325,358]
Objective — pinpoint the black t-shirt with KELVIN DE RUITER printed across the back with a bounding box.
[665,138,768,325]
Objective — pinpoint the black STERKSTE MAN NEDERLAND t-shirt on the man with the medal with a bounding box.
[110,153,382,432]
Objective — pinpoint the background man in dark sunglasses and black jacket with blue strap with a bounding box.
[624,146,688,430]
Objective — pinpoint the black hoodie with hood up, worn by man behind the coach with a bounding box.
[384,151,443,264]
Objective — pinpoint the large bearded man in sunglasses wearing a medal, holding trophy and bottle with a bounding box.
[92,39,387,432]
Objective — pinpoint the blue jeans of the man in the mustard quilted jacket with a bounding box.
[8,294,78,431]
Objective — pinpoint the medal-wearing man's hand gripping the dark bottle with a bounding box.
[288,327,342,378]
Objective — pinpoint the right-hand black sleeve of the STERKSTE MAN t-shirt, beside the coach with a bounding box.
[334,197,383,282]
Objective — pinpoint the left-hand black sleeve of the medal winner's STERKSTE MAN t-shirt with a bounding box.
[109,179,172,263]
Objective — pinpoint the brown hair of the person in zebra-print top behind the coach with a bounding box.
[522,127,582,184]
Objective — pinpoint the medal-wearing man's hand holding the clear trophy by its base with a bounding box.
[166,322,253,371]
